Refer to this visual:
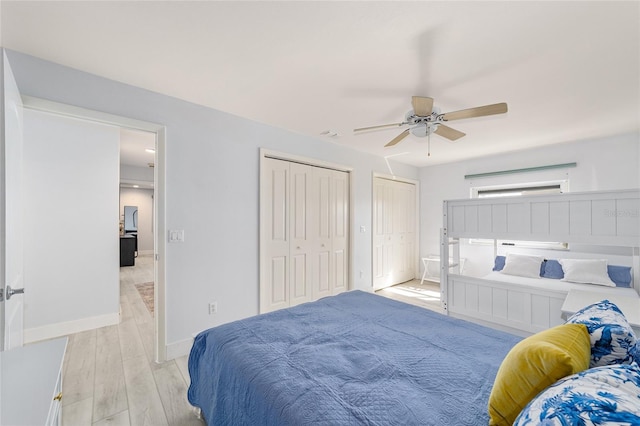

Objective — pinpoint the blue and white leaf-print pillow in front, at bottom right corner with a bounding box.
[513,364,640,426]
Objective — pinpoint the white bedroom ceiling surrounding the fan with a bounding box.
[1,0,640,166]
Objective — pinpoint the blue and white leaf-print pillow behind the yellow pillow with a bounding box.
[567,300,636,367]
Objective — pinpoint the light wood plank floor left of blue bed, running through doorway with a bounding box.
[62,255,204,426]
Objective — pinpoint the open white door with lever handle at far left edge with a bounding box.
[0,51,24,350]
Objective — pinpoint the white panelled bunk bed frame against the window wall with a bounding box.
[440,190,640,336]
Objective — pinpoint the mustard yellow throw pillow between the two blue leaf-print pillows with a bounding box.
[489,324,591,426]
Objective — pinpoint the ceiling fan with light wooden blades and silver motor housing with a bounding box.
[353,96,507,155]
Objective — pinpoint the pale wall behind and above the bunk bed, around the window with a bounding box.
[420,133,640,276]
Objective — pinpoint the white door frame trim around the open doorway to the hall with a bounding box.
[23,96,166,362]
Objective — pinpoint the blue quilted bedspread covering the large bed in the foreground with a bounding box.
[188,291,520,426]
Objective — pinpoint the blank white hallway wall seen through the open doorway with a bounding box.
[23,110,120,341]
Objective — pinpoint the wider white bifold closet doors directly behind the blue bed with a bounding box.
[260,159,349,312]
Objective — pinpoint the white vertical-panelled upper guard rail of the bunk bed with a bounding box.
[444,190,640,247]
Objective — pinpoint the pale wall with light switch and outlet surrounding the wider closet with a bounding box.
[8,51,418,356]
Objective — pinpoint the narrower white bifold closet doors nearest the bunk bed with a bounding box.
[373,178,416,290]
